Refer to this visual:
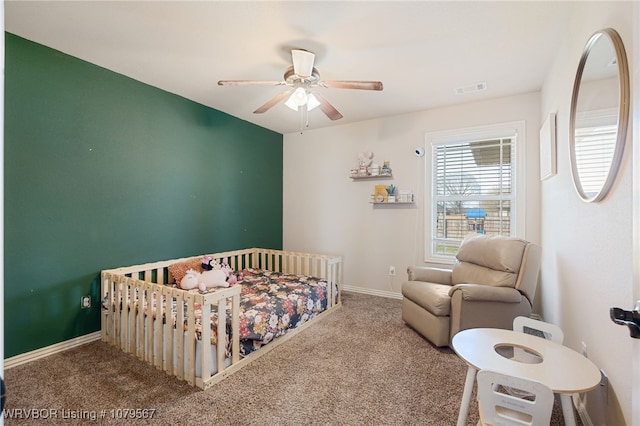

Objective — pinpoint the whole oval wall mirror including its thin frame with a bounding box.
[569,28,629,202]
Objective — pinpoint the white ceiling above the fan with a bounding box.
[5,0,580,134]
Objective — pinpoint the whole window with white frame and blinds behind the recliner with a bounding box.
[425,123,524,261]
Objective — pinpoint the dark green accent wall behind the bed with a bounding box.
[4,33,282,357]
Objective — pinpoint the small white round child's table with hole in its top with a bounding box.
[451,328,600,426]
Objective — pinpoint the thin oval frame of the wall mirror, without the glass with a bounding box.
[569,28,630,202]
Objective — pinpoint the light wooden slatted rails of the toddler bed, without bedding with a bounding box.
[101,248,342,389]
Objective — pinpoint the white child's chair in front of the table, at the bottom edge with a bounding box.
[477,370,554,426]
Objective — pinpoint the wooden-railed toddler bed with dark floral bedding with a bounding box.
[101,248,342,389]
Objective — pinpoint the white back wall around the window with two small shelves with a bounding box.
[283,93,540,297]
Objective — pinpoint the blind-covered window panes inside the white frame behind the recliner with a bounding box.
[431,135,516,256]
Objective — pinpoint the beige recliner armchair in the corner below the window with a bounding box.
[402,235,541,346]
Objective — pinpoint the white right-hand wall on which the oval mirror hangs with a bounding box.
[541,2,638,425]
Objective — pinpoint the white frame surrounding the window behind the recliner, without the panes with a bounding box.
[423,120,527,264]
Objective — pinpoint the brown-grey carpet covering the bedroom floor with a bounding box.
[5,292,564,425]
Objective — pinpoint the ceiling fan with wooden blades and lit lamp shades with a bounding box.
[218,49,382,120]
